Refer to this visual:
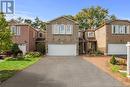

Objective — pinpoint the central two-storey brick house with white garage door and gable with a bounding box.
[46,17,79,56]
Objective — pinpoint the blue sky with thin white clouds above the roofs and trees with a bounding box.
[7,0,130,21]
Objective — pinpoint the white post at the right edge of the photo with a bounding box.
[126,42,130,78]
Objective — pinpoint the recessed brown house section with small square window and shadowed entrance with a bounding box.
[78,29,97,54]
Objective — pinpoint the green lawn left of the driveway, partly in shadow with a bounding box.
[0,58,40,81]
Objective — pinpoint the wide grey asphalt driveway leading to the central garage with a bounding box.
[1,57,123,87]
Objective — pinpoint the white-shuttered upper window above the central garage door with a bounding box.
[52,24,73,34]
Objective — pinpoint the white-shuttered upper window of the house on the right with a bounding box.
[112,25,130,34]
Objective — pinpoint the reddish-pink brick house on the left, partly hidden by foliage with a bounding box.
[9,19,38,54]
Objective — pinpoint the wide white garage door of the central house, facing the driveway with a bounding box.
[48,44,76,56]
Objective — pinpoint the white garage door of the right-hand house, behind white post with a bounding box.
[108,44,127,55]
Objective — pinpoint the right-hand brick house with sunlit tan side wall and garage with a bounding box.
[95,20,130,55]
